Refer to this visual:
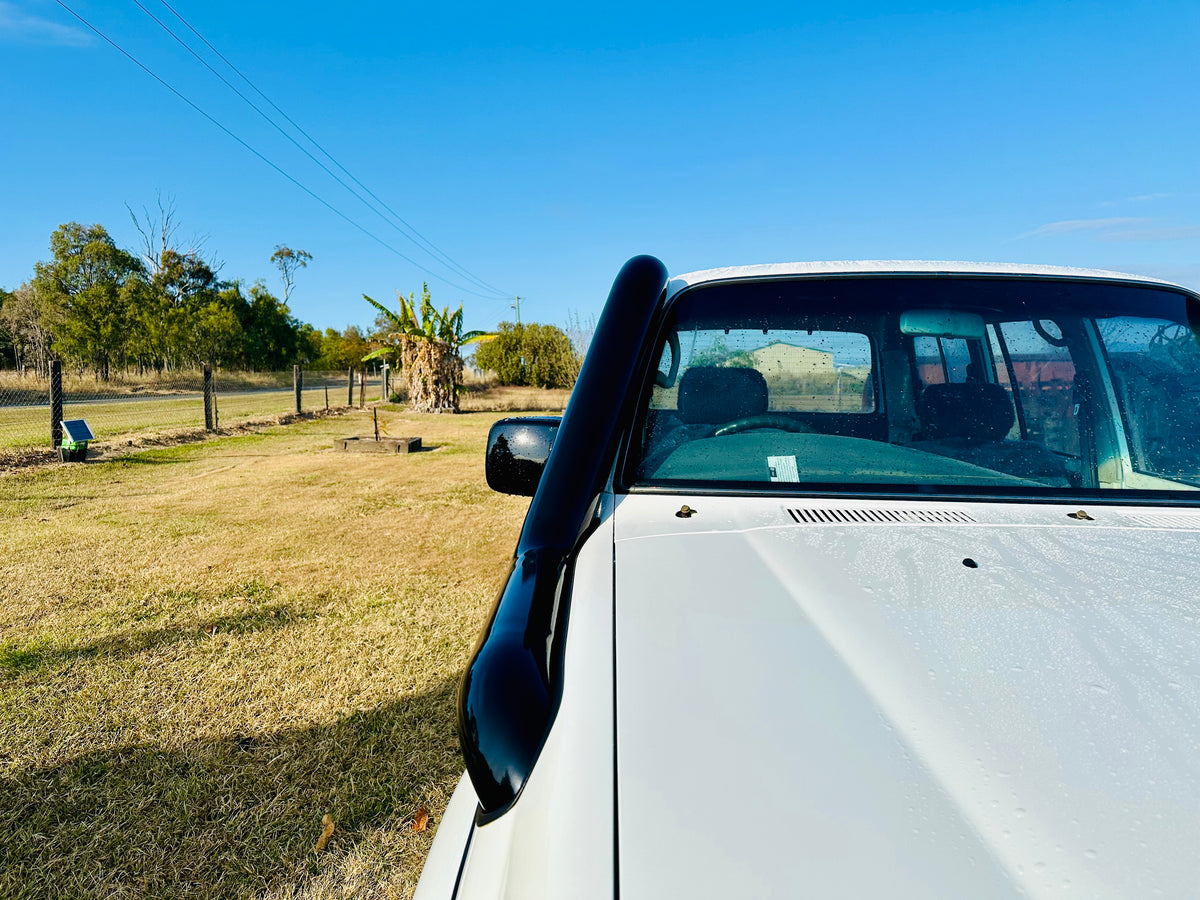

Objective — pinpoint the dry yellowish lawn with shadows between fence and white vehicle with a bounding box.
[0,409,537,899]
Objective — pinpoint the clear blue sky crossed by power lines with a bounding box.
[0,0,1200,336]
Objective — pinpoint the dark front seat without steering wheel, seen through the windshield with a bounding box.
[910,382,1070,487]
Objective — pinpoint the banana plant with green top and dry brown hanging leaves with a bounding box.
[362,284,492,413]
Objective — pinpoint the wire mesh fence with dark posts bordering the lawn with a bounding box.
[0,370,383,451]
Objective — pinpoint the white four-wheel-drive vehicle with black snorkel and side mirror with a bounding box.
[418,257,1200,900]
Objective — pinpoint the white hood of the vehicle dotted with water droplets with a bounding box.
[616,496,1200,900]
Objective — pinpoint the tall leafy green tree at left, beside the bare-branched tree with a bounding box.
[34,222,145,382]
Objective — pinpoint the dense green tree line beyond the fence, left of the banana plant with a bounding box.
[0,224,370,380]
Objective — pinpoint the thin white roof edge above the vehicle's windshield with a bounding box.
[666,259,1194,298]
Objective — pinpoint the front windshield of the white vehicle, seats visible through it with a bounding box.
[629,276,1200,499]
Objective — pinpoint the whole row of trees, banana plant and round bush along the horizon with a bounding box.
[0,217,594,392]
